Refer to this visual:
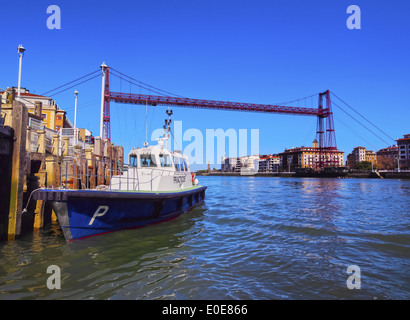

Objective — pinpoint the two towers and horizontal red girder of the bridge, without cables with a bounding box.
[98,65,338,169]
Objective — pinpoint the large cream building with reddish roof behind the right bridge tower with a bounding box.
[279,139,344,171]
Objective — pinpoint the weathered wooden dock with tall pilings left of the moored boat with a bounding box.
[0,89,123,241]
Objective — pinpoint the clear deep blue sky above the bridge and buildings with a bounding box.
[0,0,410,167]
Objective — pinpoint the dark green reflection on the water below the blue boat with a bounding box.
[0,208,205,299]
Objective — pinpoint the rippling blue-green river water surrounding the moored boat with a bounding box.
[0,176,410,300]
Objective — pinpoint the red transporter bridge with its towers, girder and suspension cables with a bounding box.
[43,63,340,169]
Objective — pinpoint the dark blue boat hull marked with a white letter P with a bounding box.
[34,186,206,241]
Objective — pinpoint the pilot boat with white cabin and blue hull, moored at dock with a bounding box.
[33,110,206,241]
